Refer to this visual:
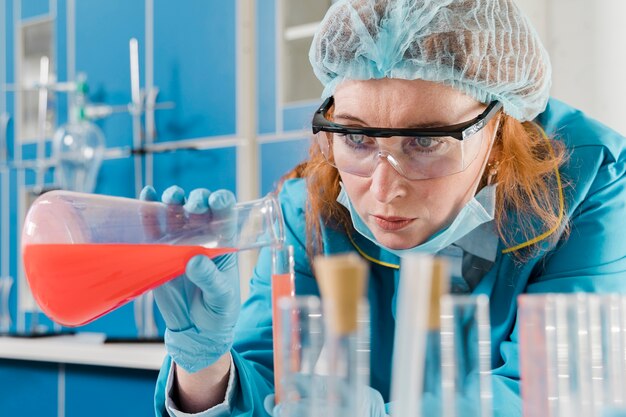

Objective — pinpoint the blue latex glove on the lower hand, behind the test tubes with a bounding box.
[263,375,388,417]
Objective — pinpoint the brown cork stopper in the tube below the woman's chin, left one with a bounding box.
[314,253,367,336]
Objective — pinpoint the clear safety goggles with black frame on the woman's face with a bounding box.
[312,96,502,180]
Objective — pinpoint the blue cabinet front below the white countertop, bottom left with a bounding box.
[0,360,157,417]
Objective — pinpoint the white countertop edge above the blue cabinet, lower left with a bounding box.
[0,333,165,370]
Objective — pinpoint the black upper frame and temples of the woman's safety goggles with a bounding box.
[312,96,502,140]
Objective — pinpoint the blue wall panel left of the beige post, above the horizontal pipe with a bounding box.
[154,0,236,141]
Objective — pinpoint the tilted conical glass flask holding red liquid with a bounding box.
[22,191,284,326]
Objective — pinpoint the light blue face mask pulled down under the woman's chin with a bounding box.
[337,184,497,258]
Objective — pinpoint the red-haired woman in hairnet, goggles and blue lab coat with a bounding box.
[151,0,626,416]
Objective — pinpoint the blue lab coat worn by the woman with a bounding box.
[156,100,626,417]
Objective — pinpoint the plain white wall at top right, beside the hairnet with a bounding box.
[517,0,626,135]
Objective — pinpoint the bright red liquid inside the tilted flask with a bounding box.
[23,244,235,326]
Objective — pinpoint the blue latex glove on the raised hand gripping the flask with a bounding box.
[139,186,241,372]
